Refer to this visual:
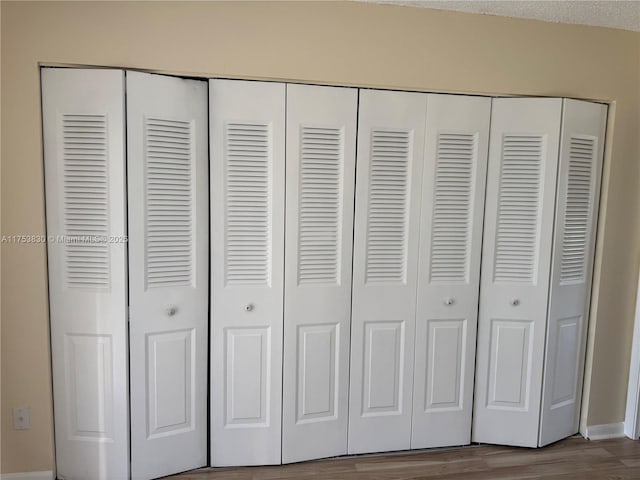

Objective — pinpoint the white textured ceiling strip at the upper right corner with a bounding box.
[362,0,640,32]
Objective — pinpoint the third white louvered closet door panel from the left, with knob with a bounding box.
[209,80,285,466]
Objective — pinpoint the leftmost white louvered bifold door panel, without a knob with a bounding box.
[42,68,129,480]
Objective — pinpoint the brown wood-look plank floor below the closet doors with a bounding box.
[166,436,640,480]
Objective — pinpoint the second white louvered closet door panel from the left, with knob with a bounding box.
[126,72,209,479]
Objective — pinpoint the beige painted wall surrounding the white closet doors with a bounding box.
[1,1,640,472]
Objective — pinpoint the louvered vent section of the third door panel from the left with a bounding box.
[224,123,272,286]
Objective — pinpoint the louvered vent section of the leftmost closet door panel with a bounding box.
[62,114,109,288]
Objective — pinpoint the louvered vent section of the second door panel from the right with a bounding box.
[494,134,544,283]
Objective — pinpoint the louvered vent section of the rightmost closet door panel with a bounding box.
[560,136,595,283]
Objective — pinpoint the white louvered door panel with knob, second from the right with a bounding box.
[472,98,562,447]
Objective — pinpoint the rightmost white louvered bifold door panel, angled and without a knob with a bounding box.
[539,99,607,446]
